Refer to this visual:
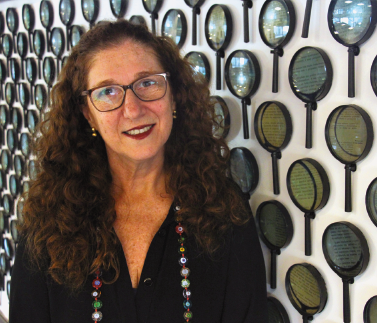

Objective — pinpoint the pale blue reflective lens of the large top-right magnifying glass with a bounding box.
[332,0,372,45]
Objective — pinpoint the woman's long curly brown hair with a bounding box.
[20,20,248,289]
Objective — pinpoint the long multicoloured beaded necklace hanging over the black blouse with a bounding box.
[91,206,192,323]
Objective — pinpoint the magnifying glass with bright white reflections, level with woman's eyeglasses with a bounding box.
[225,50,261,139]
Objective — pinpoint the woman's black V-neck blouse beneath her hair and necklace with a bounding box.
[9,204,268,323]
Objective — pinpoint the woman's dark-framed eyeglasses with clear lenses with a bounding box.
[81,73,169,112]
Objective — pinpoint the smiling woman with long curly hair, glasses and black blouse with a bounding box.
[10,20,267,323]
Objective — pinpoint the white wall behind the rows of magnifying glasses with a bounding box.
[0,0,377,323]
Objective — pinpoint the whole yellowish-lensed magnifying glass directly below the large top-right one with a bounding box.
[325,104,374,212]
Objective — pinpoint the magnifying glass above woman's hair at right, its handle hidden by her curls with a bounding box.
[161,9,187,48]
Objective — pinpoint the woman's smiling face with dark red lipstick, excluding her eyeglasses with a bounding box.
[83,41,175,170]
